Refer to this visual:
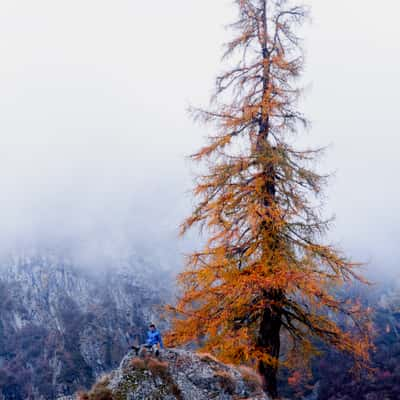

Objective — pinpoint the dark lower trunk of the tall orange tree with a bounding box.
[258,290,282,399]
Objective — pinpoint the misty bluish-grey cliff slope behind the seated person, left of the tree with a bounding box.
[0,253,172,400]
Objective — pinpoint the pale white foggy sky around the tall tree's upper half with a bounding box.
[0,0,400,276]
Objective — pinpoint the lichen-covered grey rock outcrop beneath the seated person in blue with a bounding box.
[85,350,268,400]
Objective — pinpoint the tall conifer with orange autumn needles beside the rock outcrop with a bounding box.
[168,0,370,398]
